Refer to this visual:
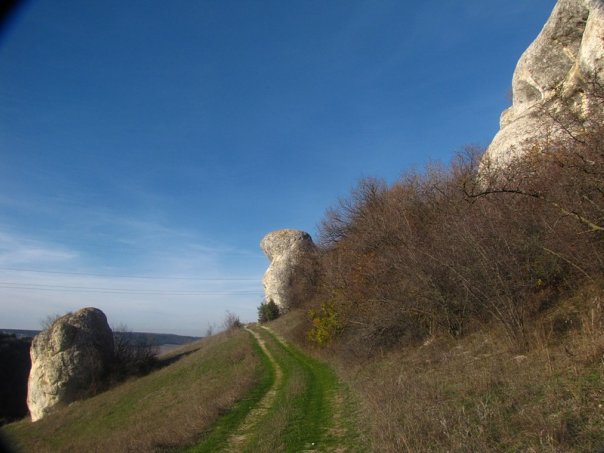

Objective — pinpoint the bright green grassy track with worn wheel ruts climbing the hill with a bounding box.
[189,327,366,452]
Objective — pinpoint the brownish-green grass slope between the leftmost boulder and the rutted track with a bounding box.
[5,331,263,452]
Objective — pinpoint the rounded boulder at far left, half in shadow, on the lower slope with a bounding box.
[27,307,114,421]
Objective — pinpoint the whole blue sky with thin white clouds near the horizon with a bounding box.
[0,0,555,335]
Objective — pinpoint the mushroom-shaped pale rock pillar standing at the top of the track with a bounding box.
[260,230,316,311]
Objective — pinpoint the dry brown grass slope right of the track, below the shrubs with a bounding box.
[271,296,604,452]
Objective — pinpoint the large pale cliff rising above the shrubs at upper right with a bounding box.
[486,0,604,165]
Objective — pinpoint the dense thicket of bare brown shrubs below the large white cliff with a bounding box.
[309,92,604,354]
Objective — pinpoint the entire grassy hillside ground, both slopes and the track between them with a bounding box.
[6,304,604,452]
